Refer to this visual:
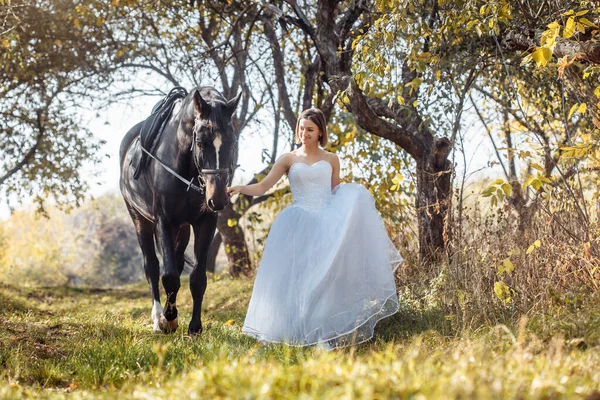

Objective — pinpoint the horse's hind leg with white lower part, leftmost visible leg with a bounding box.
[127,205,163,332]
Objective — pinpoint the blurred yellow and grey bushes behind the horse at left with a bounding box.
[0,196,144,286]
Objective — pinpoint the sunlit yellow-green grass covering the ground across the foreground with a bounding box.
[0,276,600,399]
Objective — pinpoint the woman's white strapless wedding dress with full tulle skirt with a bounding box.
[242,160,402,348]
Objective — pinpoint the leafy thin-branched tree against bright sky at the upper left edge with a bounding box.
[0,0,124,211]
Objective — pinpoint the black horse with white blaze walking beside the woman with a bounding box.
[120,87,241,335]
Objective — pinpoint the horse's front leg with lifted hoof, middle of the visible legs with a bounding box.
[154,218,180,333]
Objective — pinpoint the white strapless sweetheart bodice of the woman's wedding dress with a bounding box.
[288,160,332,210]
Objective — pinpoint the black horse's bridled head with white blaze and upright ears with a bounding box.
[191,88,241,211]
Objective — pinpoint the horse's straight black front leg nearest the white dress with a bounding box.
[188,213,217,336]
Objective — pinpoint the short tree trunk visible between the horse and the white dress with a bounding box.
[215,204,251,277]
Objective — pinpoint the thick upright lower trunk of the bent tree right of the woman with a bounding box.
[415,138,452,264]
